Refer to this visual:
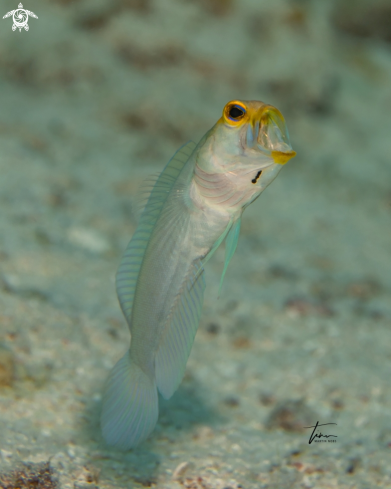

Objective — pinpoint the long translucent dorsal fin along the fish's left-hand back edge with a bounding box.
[116,141,196,327]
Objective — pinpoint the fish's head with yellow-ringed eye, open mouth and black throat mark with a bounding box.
[198,100,296,207]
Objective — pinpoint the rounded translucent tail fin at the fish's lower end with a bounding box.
[101,351,158,450]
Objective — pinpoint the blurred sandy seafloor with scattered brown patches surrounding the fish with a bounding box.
[0,0,391,489]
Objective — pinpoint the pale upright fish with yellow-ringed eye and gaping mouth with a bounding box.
[101,100,296,450]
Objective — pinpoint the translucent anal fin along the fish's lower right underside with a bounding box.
[155,262,205,399]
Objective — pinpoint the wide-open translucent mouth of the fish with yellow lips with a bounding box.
[246,106,296,165]
